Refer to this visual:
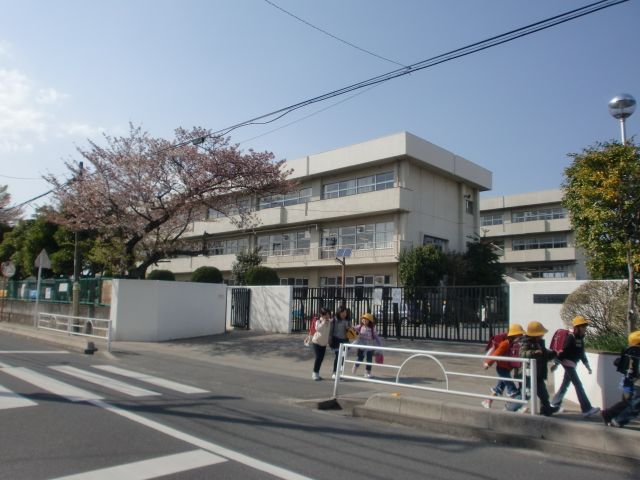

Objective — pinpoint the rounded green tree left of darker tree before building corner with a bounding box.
[399,245,447,288]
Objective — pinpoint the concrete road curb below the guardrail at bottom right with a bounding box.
[353,394,640,466]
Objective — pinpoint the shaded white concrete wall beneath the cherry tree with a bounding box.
[111,279,227,342]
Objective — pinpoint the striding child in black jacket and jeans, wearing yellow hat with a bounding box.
[551,315,600,418]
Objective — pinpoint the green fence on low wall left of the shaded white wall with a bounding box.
[2,278,111,305]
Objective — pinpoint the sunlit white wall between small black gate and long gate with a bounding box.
[226,286,293,333]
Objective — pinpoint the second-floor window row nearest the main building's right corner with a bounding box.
[321,222,394,250]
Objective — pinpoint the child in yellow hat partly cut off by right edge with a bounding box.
[600,330,640,428]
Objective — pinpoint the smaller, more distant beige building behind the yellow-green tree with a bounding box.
[480,189,589,280]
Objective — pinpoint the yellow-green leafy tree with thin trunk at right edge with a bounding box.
[562,142,640,331]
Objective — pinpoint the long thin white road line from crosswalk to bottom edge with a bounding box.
[89,400,311,480]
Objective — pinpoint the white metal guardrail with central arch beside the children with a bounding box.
[333,343,538,415]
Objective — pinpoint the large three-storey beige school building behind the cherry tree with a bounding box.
[159,132,492,287]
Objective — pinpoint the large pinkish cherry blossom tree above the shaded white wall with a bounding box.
[47,125,290,278]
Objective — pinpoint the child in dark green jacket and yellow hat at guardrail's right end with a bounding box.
[520,321,557,417]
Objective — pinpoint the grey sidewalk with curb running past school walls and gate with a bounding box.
[0,322,640,462]
